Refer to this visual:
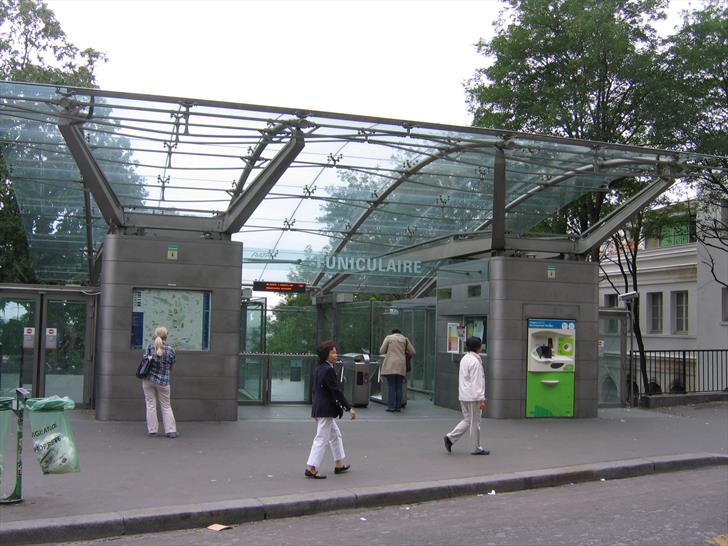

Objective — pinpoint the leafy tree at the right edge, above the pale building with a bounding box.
[653,0,728,287]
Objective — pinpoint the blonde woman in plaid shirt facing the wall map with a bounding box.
[142,326,177,438]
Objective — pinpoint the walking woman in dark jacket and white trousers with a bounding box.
[306,341,356,480]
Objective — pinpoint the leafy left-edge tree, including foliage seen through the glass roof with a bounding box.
[0,0,151,282]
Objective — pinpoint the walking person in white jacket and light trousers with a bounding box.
[445,336,490,455]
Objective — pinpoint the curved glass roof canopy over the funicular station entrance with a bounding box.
[0,82,716,293]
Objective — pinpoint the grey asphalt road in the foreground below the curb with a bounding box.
[54,466,728,546]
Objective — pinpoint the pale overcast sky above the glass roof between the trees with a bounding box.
[47,0,501,125]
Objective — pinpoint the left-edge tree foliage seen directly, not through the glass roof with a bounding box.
[0,0,105,283]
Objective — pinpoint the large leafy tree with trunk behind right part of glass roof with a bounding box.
[466,0,725,396]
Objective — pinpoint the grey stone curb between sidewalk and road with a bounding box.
[0,453,728,544]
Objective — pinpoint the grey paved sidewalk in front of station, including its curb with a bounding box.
[0,398,728,544]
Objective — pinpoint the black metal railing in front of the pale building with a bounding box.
[630,349,728,394]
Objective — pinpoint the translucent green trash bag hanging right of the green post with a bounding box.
[25,396,80,474]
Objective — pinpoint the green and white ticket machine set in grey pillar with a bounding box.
[526,319,576,417]
